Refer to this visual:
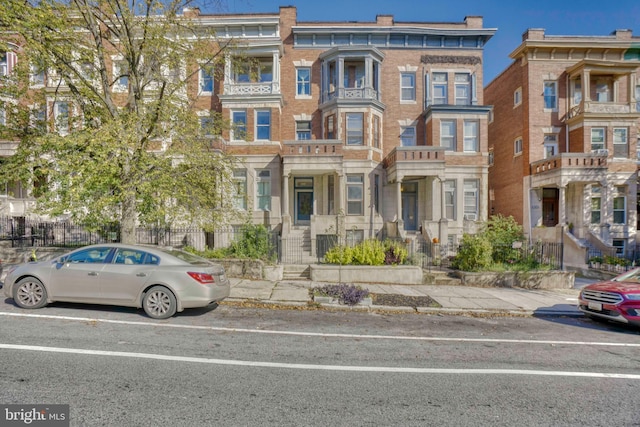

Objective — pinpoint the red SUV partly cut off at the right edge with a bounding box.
[578,268,640,326]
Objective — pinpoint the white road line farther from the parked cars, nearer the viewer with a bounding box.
[0,344,640,380]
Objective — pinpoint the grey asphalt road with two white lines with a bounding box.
[0,300,640,426]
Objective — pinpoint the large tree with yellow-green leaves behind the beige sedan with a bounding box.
[0,0,242,243]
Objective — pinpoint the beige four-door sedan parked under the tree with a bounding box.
[4,243,230,319]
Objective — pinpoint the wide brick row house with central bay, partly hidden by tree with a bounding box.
[0,6,495,256]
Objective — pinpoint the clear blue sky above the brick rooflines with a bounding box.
[200,0,640,85]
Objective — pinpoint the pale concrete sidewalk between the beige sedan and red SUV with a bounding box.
[225,278,581,316]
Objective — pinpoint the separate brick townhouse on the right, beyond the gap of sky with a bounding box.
[485,29,640,265]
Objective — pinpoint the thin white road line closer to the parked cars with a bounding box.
[0,312,640,348]
